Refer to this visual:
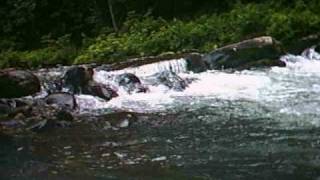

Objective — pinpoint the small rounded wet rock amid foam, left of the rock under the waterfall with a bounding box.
[116,73,148,93]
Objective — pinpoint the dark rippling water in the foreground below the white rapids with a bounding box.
[0,102,320,180]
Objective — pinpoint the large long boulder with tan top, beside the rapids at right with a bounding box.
[203,36,285,70]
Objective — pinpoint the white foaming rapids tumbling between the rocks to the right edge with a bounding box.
[77,48,320,125]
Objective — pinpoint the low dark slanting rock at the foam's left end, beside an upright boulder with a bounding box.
[83,81,118,101]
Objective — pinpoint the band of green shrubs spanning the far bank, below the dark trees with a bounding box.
[0,0,320,67]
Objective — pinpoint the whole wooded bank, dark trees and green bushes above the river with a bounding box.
[0,0,320,67]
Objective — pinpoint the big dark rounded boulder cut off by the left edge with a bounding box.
[0,69,41,98]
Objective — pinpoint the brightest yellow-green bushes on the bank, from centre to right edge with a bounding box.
[76,3,320,63]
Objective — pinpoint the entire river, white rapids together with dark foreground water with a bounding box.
[0,49,320,180]
